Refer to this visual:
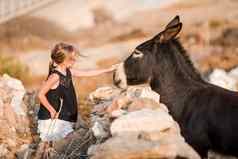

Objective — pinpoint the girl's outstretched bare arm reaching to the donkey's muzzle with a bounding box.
[70,65,116,77]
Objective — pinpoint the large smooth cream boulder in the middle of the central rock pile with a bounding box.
[111,108,174,135]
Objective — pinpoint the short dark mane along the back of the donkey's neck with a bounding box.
[173,38,202,79]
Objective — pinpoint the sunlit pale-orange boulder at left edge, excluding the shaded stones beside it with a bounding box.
[0,74,31,158]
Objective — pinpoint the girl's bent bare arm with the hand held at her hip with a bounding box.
[38,73,59,118]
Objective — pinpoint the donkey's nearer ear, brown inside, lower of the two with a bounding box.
[155,23,182,43]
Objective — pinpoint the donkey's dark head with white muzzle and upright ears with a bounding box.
[114,16,182,88]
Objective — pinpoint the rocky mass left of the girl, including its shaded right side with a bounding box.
[0,74,37,158]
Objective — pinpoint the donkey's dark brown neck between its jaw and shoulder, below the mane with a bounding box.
[150,42,201,120]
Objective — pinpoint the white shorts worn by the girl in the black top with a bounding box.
[37,119,74,141]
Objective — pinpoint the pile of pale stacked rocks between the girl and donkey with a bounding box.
[88,85,200,159]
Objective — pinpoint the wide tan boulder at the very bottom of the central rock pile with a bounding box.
[92,133,200,159]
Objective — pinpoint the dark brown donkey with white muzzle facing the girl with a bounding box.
[113,16,238,158]
